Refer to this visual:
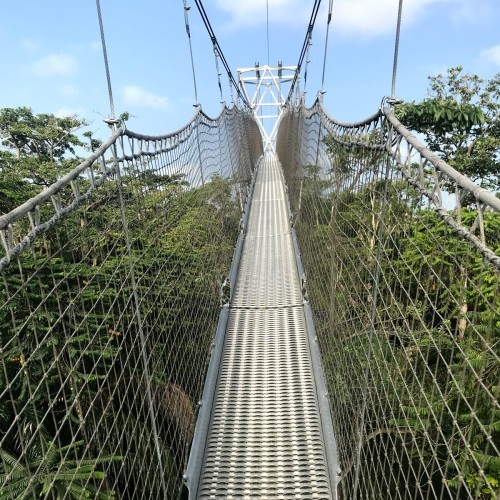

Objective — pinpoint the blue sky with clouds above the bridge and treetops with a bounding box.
[0,0,500,138]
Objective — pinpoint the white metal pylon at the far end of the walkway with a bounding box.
[237,62,298,152]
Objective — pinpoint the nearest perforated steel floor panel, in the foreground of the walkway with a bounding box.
[199,307,331,498]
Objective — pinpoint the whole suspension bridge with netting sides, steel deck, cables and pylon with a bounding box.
[0,0,500,500]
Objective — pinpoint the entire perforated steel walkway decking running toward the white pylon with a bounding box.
[189,158,334,499]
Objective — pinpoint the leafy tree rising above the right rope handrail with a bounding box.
[396,66,500,191]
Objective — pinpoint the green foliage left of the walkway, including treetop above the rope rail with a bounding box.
[0,108,246,499]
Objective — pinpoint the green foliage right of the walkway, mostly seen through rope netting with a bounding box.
[294,118,500,500]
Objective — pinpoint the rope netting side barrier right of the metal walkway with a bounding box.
[277,101,500,500]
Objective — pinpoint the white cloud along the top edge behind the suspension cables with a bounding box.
[217,0,456,36]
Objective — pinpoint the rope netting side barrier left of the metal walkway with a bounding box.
[0,108,262,499]
